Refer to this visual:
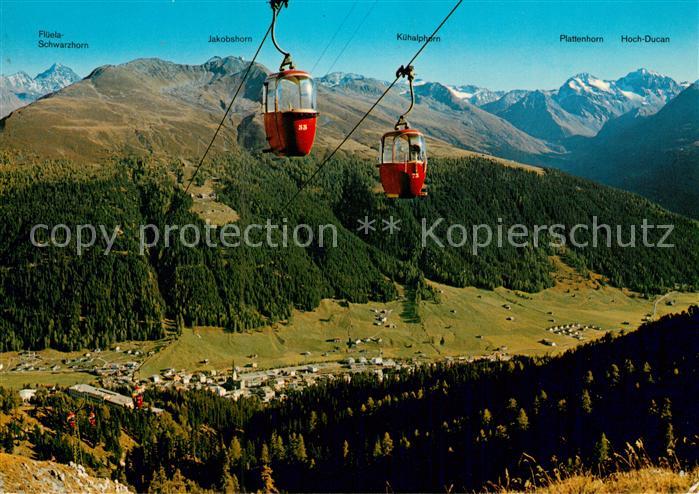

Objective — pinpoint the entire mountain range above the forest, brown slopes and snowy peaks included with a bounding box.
[0,57,699,217]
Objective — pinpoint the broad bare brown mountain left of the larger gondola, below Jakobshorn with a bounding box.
[0,57,266,162]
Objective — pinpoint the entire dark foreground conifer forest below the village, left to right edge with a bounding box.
[0,307,699,492]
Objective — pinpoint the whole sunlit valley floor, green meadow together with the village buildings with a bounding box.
[0,287,696,413]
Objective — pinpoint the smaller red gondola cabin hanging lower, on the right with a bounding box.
[379,128,427,199]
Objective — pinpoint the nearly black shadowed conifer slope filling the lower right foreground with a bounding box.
[235,308,699,492]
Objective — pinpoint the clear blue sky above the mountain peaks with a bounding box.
[0,0,699,89]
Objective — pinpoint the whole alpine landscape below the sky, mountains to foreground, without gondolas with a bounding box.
[0,57,699,493]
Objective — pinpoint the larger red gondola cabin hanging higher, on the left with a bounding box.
[264,69,318,156]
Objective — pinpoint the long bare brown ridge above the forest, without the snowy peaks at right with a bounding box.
[0,57,556,162]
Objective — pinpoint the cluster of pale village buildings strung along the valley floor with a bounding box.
[5,338,510,413]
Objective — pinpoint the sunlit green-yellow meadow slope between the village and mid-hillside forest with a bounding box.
[141,264,699,376]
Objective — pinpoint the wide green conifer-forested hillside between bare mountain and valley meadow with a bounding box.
[0,152,699,351]
